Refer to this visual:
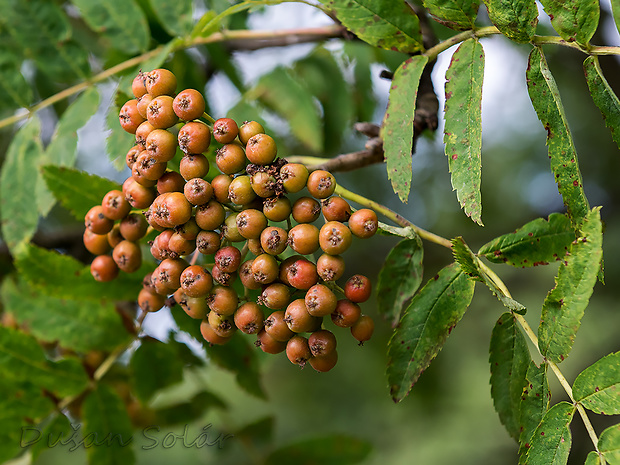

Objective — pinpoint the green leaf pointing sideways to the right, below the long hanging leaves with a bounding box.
[478,213,575,268]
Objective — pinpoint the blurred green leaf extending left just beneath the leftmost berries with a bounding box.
[15,244,149,301]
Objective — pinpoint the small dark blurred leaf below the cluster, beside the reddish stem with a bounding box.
[129,339,183,403]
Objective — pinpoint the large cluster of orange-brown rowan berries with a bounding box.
[84,69,378,371]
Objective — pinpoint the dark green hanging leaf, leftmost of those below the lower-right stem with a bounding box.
[489,313,530,441]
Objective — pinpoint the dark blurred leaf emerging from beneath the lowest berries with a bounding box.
[206,334,267,399]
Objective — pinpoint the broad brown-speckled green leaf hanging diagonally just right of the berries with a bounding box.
[387,263,474,402]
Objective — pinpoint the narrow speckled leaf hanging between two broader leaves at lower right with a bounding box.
[519,362,551,465]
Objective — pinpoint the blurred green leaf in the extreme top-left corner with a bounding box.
[0,0,90,80]
